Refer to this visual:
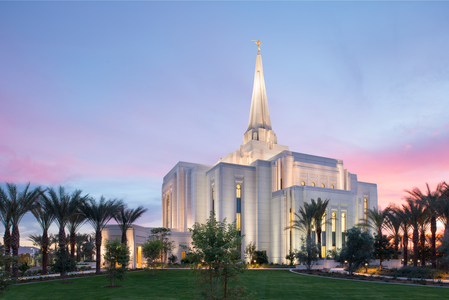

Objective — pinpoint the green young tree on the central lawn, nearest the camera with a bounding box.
[189,212,246,299]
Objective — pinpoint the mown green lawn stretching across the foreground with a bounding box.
[2,270,449,300]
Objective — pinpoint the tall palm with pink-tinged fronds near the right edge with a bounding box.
[405,183,444,268]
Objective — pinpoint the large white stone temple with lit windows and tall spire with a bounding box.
[101,44,377,267]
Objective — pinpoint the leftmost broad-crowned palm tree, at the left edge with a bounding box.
[0,183,40,278]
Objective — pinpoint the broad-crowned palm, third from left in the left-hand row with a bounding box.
[42,186,87,278]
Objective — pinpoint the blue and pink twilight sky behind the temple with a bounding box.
[0,1,449,245]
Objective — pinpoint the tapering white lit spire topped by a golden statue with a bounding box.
[243,40,277,144]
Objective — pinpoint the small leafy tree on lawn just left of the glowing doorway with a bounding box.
[103,239,130,287]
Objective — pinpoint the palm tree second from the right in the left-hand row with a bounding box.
[80,196,123,274]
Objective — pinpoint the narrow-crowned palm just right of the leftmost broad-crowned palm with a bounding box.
[30,196,55,274]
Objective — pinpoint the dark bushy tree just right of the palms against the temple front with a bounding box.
[339,227,374,275]
